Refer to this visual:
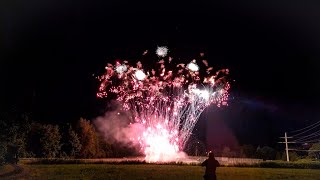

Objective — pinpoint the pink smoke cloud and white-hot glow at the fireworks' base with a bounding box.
[94,102,186,162]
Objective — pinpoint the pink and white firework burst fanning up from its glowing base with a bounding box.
[97,47,230,162]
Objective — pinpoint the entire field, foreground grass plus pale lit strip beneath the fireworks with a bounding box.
[0,157,320,180]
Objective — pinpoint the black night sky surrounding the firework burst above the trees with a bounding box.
[0,0,320,148]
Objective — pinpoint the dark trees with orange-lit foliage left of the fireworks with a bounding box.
[0,113,137,164]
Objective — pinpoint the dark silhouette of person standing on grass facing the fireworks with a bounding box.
[201,152,220,180]
